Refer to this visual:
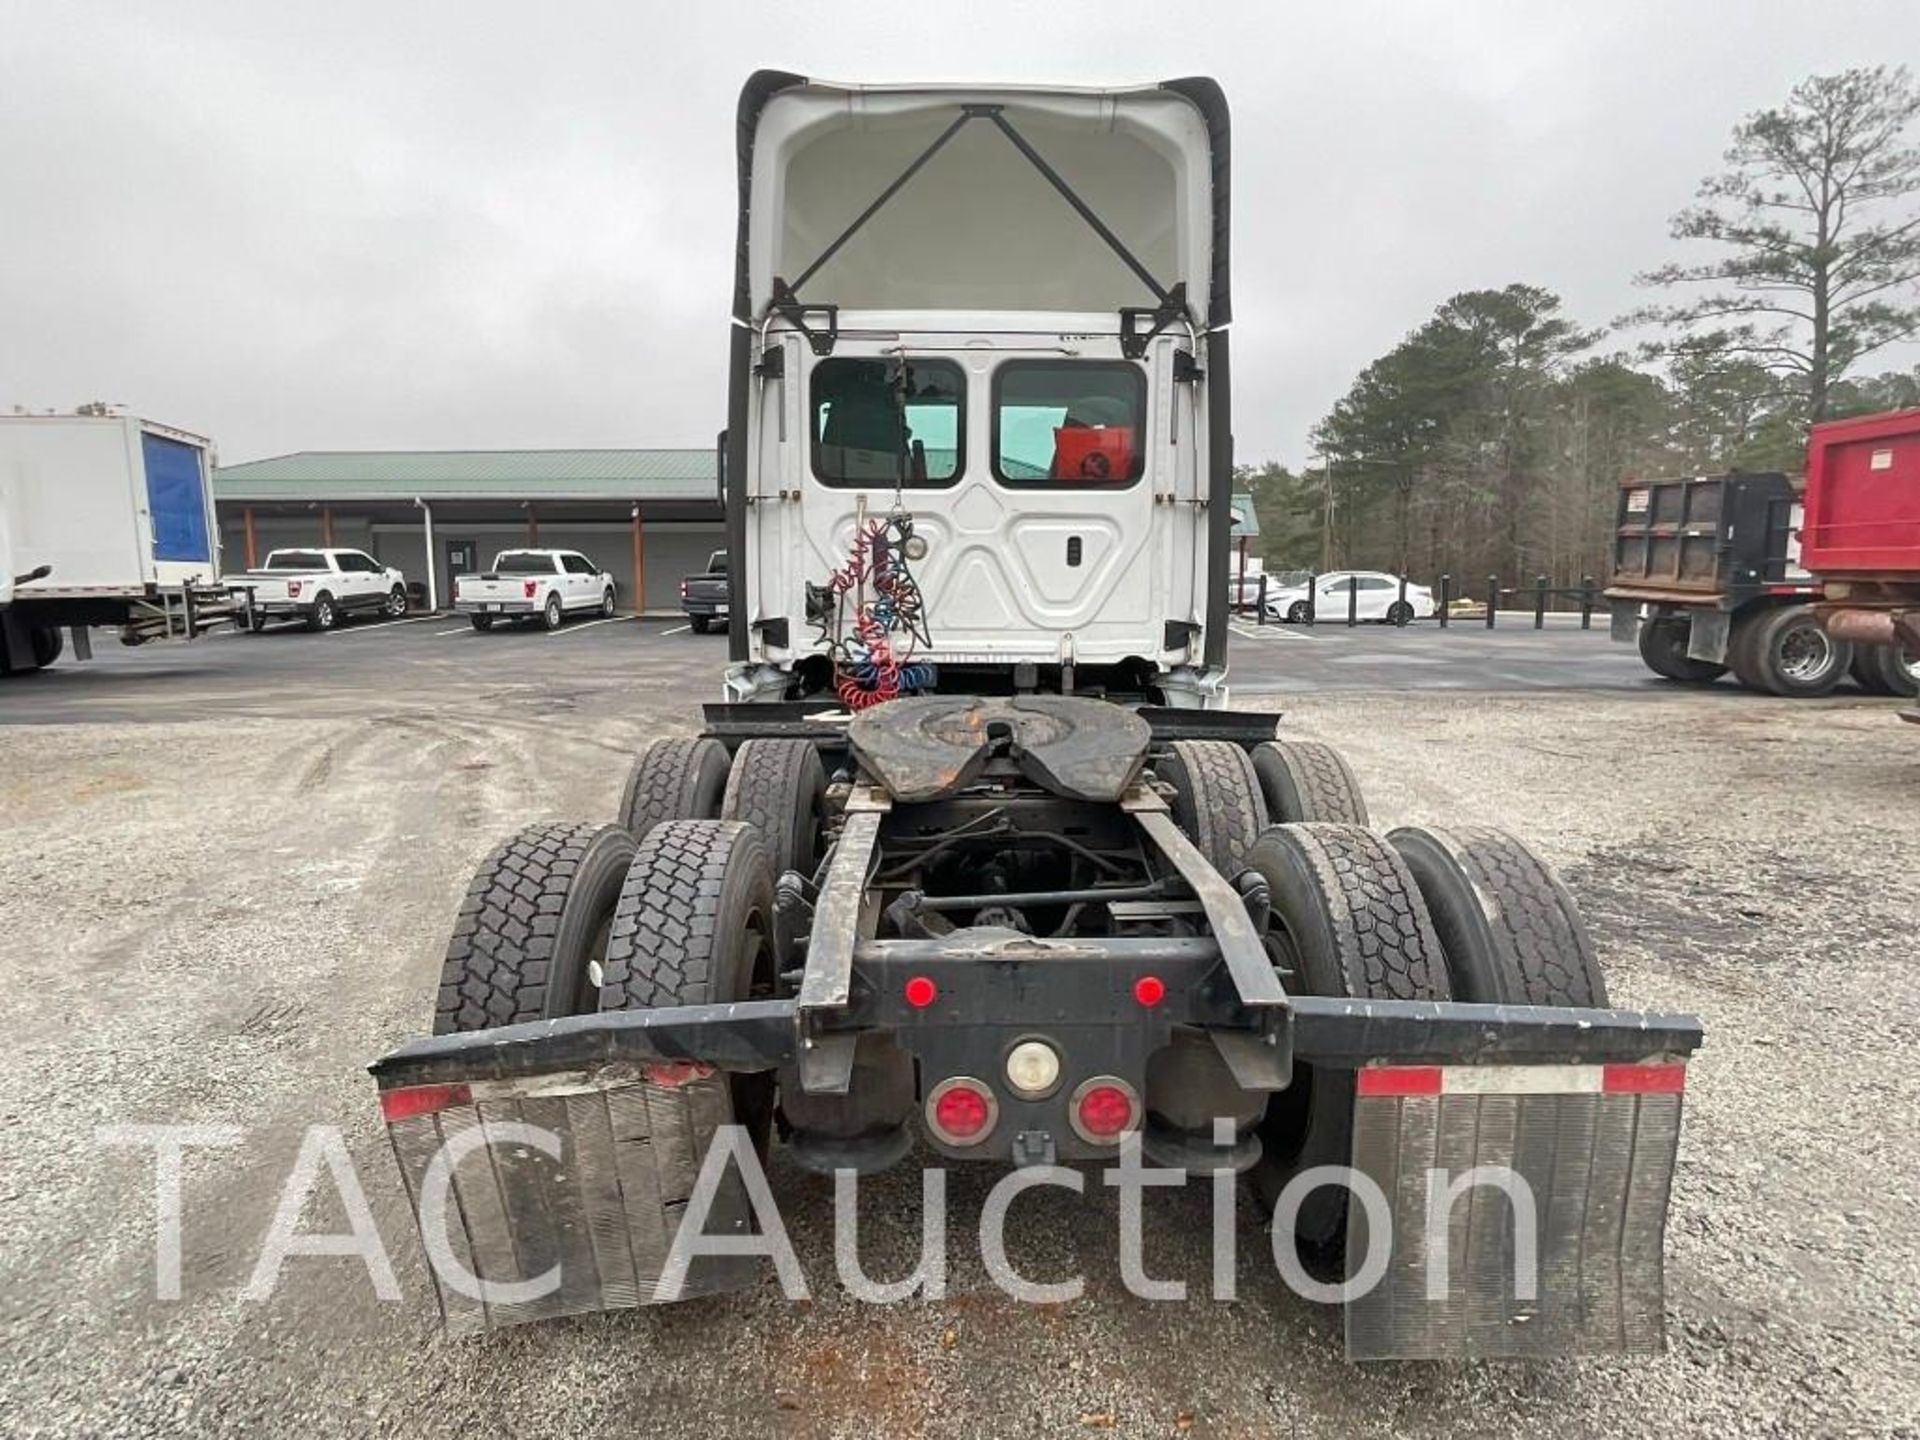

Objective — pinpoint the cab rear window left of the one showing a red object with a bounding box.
[812,357,966,490]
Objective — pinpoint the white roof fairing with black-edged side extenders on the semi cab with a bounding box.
[726,71,1233,683]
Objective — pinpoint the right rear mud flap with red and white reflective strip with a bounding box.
[1346,1066,1682,1359]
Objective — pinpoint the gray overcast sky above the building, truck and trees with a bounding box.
[0,0,1920,463]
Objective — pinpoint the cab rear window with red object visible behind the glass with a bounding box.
[993,361,1146,490]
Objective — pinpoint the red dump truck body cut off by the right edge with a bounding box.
[1801,409,1920,724]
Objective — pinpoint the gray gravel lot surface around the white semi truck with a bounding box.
[0,684,1920,1440]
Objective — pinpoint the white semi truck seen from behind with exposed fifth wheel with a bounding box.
[372,71,1701,1357]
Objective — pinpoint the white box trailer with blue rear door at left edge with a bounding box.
[0,415,227,674]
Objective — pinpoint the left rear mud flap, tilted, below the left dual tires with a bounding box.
[388,1066,764,1334]
